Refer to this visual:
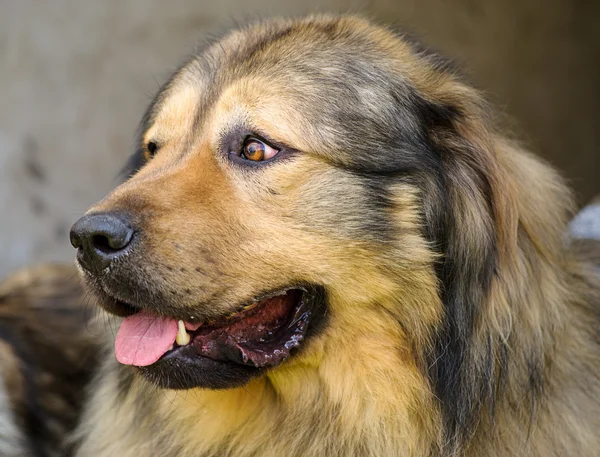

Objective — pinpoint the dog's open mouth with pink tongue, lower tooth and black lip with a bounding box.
[106,286,325,388]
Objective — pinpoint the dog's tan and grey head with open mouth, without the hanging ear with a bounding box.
[72,18,502,396]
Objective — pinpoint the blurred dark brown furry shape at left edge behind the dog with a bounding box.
[0,266,97,457]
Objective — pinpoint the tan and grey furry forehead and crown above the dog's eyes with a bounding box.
[144,18,432,169]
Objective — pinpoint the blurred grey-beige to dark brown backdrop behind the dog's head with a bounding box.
[0,0,600,276]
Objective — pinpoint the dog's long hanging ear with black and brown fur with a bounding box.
[417,85,517,441]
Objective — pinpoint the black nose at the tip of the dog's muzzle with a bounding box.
[70,213,134,273]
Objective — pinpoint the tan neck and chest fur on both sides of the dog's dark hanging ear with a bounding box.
[71,141,600,457]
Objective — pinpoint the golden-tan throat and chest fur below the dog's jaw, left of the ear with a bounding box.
[71,314,440,457]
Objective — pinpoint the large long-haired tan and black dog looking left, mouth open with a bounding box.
[44,16,600,457]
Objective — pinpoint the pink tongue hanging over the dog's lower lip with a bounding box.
[115,311,177,367]
